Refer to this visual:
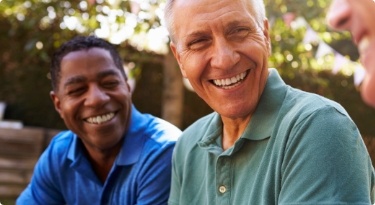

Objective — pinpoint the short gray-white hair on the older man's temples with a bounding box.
[164,0,266,42]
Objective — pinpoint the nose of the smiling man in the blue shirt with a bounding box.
[85,86,110,107]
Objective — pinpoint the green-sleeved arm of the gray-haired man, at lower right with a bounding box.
[279,107,374,205]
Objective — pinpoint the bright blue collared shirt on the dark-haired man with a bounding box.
[17,106,181,205]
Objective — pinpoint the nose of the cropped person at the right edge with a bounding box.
[327,0,352,30]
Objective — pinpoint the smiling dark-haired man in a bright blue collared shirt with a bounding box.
[17,36,181,205]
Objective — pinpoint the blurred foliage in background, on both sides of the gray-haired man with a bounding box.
[0,0,375,136]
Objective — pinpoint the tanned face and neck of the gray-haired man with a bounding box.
[169,0,271,149]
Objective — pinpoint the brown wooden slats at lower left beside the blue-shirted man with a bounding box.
[0,127,46,199]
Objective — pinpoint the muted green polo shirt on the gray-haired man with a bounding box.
[168,69,375,205]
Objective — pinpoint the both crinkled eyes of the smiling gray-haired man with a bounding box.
[187,27,251,50]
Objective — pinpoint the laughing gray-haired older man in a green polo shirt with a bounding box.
[165,0,375,205]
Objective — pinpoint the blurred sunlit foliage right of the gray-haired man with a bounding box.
[265,0,375,136]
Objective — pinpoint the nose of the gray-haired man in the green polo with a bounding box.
[210,39,240,69]
